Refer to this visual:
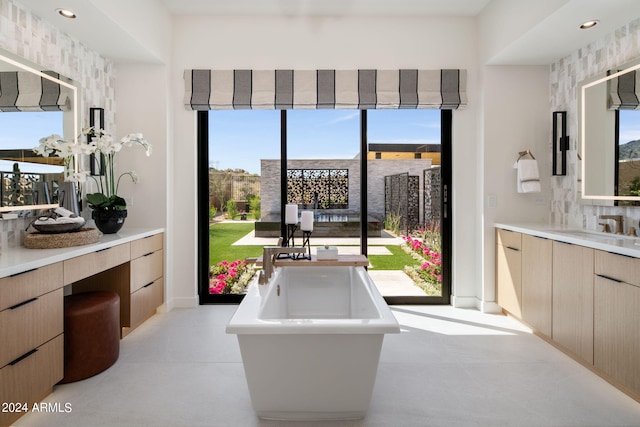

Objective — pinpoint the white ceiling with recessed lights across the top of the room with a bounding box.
[17,0,640,65]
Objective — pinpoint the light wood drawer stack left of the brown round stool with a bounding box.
[0,262,64,426]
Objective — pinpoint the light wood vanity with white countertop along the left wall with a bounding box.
[0,228,164,426]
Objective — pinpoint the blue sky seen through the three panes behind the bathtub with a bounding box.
[209,110,440,173]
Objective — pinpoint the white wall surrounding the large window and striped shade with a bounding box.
[168,13,481,306]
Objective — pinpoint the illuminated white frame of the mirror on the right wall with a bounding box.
[578,60,640,205]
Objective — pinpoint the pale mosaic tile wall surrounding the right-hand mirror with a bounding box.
[549,19,640,229]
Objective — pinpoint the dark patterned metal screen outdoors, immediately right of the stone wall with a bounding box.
[384,172,420,234]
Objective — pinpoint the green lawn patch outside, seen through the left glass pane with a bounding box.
[209,222,262,265]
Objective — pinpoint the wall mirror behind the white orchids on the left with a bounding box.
[0,50,78,212]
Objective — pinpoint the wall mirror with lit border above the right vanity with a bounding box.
[578,56,640,206]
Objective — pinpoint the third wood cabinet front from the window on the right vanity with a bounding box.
[551,241,594,364]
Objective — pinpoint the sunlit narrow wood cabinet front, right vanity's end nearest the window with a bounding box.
[496,229,522,318]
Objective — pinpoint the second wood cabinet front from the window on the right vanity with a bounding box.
[522,234,553,337]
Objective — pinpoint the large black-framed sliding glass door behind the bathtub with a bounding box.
[198,110,451,304]
